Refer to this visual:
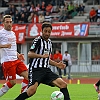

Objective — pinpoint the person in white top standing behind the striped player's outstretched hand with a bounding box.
[63,51,72,79]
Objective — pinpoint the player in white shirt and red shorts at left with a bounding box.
[0,15,28,96]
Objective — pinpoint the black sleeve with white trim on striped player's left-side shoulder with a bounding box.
[30,38,41,52]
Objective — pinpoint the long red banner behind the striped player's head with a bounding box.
[28,23,89,37]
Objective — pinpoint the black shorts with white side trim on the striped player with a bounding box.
[29,68,59,86]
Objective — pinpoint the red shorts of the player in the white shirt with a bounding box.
[2,60,28,80]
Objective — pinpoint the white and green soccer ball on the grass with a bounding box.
[51,91,64,100]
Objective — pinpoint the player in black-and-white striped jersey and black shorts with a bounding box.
[15,22,70,100]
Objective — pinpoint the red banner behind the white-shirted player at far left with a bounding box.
[0,24,26,43]
